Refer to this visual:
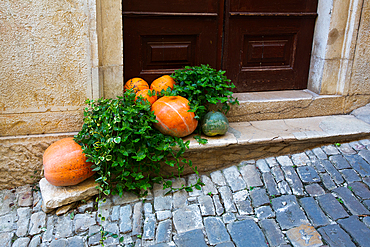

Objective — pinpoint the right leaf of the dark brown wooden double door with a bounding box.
[223,0,317,92]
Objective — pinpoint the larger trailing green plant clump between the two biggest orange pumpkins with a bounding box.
[75,90,192,196]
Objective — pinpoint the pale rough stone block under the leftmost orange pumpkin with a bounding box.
[39,178,98,213]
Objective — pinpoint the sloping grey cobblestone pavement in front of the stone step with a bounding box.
[0,139,370,247]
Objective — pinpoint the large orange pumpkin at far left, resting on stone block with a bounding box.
[43,137,95,186]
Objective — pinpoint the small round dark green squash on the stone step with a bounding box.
[201,111,229,136]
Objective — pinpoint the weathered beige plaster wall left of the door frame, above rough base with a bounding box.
[0,0,92,136]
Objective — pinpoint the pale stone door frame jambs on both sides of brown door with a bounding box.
[92,0,364,98]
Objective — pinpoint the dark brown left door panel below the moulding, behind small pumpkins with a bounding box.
[124,16,218,83]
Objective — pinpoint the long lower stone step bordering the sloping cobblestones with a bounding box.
[168,115,370,175]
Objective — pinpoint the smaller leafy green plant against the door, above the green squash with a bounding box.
[171,65,239,119]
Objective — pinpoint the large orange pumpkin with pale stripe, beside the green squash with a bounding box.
[151,96,198,137]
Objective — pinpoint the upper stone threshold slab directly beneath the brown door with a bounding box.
[227,89,348,122]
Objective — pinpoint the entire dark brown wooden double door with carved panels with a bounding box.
[123,0,317,92]
